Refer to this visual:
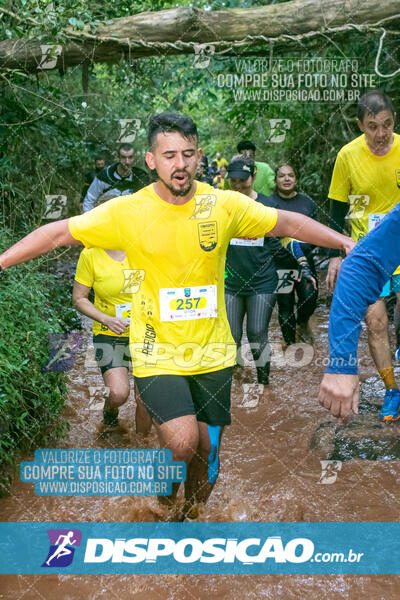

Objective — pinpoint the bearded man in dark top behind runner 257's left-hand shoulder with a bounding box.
[83,144,150,212]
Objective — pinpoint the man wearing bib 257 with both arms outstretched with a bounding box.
[0,113,354,514]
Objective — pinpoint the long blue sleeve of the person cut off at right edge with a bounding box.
[326,204,400,374]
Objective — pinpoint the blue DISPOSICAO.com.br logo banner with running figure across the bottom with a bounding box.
[0,522,400,575]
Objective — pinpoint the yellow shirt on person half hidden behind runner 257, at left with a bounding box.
[75,248,132,337]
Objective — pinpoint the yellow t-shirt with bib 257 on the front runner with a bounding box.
[69,182,278,377]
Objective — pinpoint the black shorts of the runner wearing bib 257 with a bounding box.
[135,367,232,425]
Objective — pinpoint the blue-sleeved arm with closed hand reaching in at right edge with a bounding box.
[318,204,400,421]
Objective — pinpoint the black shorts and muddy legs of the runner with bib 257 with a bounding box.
[136,367,232,510]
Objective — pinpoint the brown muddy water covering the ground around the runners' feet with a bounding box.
[0,288,400,600]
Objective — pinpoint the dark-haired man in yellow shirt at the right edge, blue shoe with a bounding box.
[327,90,400,421]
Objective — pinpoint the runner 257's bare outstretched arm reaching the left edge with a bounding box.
[0,219,81,269]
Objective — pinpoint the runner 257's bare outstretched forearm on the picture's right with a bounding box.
[267,210,355,254]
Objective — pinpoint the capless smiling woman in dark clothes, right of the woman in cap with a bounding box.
[268,164,318,345]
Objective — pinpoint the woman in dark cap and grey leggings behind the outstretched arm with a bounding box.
[225,157,280,384]
